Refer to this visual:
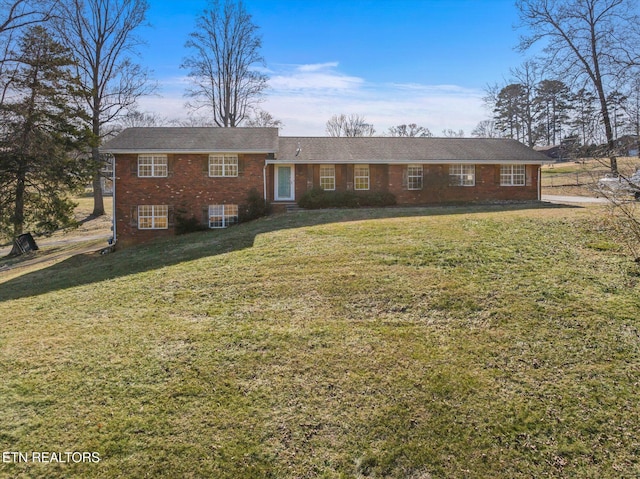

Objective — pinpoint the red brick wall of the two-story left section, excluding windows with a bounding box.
[115,154,265,245]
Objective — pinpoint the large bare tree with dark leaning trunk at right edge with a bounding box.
[516,0,640,174]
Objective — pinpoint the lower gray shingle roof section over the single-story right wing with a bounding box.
[276,137,550,163]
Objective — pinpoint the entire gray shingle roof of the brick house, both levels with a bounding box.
[100,127,550,163]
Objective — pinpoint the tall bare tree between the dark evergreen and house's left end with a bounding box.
[56,0,154,216]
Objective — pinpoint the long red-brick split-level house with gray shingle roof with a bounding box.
[101,127,549,248]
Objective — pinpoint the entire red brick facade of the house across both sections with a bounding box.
[115,153,540,245]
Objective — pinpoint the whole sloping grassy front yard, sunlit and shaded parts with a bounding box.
[0,206,640,479]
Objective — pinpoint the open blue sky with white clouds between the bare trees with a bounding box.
[139,0,525,136]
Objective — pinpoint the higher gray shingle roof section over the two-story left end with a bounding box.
[100,127,278,153]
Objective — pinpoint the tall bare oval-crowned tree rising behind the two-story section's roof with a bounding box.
[182,0,267,127]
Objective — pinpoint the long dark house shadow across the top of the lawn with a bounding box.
[0,202,579,301]
